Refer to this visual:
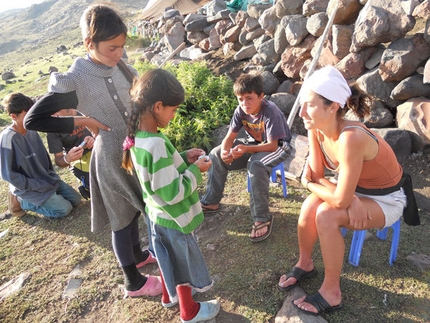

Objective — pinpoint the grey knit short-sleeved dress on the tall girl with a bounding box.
[48,58,144,232]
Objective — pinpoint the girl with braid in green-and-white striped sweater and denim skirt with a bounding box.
[123,69,220,323]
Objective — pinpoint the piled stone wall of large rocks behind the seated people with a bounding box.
[142,0,430,160]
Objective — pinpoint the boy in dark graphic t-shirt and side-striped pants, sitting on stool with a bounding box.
[201,74,291,242]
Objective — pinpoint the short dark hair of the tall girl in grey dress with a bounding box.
[80,4,127,44]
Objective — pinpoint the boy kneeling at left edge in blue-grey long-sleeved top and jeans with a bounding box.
[0,93,81,218]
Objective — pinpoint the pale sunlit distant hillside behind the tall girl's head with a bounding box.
[0,0,147,72]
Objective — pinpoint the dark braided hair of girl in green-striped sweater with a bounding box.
[122,68,185,174]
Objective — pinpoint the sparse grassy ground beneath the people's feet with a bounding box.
[0,120,430,323]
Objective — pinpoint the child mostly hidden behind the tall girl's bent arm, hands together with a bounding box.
[45,92,94,199]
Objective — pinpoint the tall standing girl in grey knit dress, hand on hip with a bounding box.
[25,4,161,297]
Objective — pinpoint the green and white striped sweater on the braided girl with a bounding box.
[131,131,204,234]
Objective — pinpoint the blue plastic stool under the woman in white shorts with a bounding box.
[341,219,400,266]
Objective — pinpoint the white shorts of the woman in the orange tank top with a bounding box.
[355,187,406,228]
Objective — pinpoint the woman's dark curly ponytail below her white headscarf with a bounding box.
[318,84,372,118]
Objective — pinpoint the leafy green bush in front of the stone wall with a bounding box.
[135,62,237,151]
